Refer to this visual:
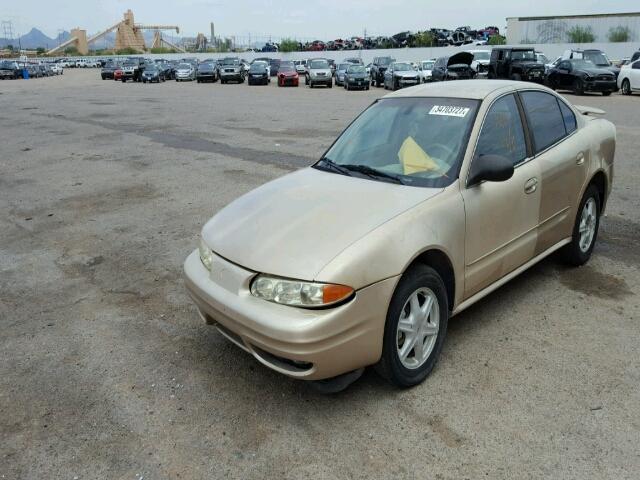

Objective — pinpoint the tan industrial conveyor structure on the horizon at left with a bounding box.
[47,10,184,55]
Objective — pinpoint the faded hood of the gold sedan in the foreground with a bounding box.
[202,168,442,280]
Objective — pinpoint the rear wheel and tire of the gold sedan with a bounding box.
[561,185,602,267]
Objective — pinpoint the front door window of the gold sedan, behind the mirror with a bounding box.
[474,95,527,165]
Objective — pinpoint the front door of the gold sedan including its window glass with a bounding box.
[462,93,540,298]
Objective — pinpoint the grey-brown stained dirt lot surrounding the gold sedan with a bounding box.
[0,70,640,480]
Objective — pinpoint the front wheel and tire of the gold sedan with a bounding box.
[376,265,449,387]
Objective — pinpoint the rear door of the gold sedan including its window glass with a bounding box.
[520,90,590,254]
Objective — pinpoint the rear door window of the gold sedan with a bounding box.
[520,92,564,153]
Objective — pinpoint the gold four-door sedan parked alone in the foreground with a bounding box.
[184,80,616,391]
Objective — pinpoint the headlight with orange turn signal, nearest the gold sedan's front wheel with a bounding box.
[251,274,353,307]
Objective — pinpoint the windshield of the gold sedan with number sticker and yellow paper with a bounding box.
[316,97,480,187]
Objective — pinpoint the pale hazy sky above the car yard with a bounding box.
[0,0,640,40]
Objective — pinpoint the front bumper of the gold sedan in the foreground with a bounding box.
[184,250,399,380]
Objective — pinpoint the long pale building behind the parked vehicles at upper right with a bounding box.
[507,12,640,45]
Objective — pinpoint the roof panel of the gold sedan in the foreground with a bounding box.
[384,80,547,100]
